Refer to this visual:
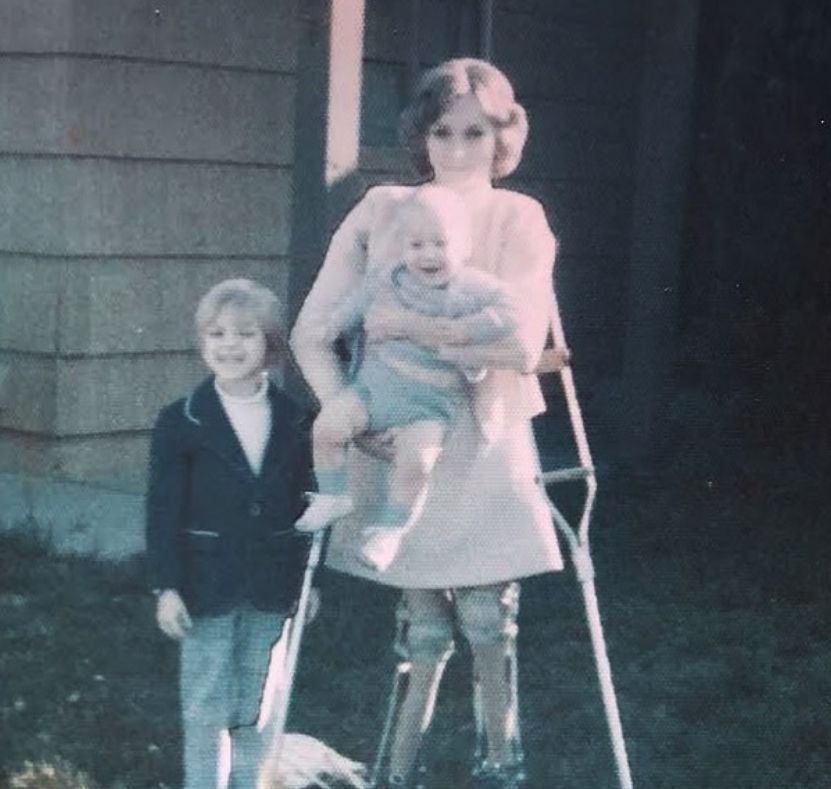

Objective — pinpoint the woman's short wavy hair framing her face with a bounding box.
[399,58,528,178]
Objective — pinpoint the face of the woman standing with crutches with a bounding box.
[427,93,496,186]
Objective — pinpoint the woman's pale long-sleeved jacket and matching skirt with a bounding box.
[291,186,563,588]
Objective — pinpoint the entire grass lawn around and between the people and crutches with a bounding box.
[0,462,831,789]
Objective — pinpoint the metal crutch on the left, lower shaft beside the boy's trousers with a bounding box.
[257,530,326,789]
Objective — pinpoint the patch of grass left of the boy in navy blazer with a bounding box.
[0,536,178,789]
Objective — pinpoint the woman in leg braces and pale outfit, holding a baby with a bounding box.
[292,59,562,787]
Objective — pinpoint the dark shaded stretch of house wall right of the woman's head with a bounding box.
[494,0,643,388]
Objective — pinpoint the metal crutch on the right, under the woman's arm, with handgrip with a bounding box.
[538,298,632,789]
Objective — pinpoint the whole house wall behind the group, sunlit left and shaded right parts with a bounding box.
[0,0,643,490]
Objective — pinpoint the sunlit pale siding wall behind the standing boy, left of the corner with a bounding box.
[0,0,298,489]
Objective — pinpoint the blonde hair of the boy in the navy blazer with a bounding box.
[195,277,289,365]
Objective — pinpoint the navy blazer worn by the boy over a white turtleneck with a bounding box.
[147,377,314,616]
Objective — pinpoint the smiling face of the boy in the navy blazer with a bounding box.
[201,304,266,396]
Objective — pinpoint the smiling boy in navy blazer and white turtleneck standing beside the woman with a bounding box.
[147,279,313,789]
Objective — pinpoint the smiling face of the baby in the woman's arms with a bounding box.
[402,206,465,288]
